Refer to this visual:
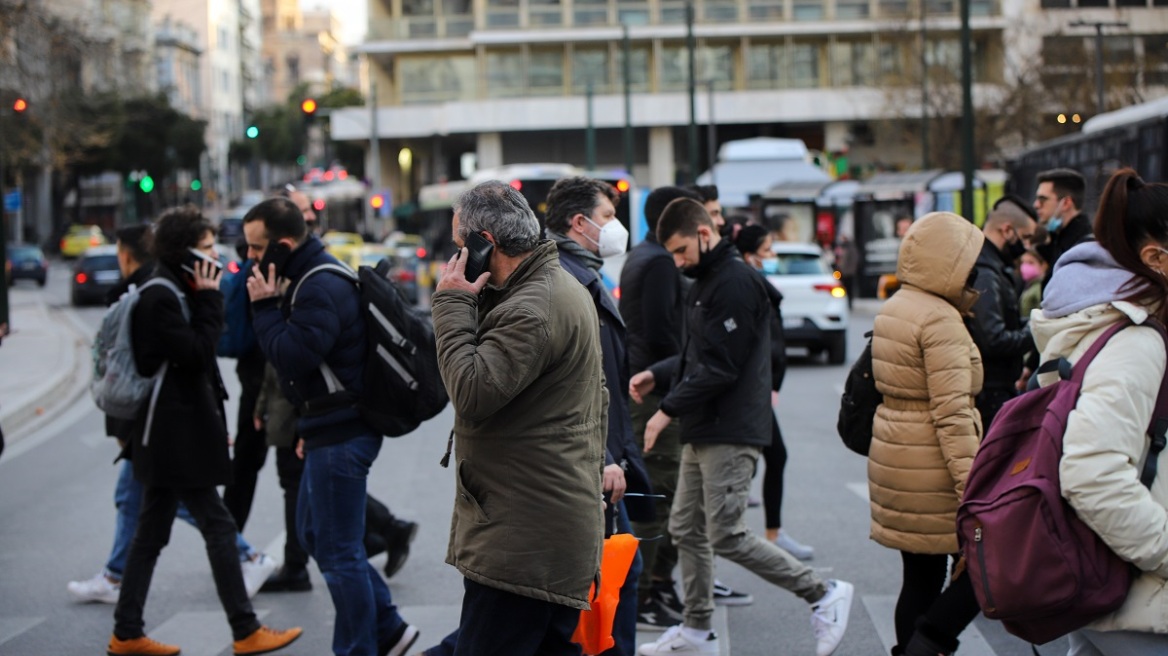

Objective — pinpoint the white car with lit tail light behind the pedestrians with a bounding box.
[766,242,849,364]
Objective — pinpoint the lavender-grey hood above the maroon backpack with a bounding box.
[1042,242,1135,319]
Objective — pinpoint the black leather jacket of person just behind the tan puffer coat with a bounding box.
[966,239,1034,391]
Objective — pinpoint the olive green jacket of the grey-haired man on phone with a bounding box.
[433,240,609,609]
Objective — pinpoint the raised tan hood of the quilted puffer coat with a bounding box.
[896,211,986,312]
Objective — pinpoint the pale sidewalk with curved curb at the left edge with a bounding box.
[0,288,89,445]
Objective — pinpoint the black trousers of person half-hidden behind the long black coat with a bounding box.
[223,348,267,531]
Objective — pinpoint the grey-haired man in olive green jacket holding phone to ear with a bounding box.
[432,182,607,656]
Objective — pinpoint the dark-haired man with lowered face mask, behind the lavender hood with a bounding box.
[1034,168,1094,289]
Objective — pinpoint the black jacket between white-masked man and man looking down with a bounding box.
[620,235,684,374]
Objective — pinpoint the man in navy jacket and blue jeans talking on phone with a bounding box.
[243,198,418,656]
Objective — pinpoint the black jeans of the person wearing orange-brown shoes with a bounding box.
[113,486,259,640]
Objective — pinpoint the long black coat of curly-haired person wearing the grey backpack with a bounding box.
[128,265,231,488]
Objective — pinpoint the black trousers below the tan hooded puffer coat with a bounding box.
[895,551,981,647]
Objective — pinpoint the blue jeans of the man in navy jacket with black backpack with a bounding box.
[297,435,404,656]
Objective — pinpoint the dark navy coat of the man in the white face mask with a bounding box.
[559,249,653,522]
